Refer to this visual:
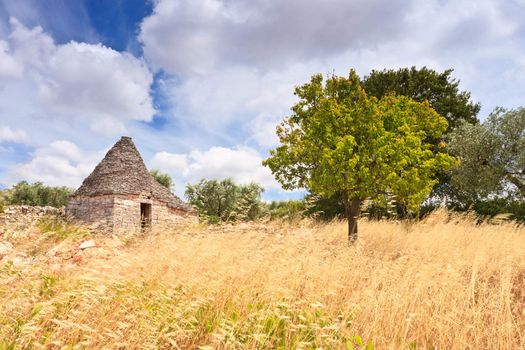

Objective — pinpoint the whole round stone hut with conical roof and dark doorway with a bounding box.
[66,137,197,234]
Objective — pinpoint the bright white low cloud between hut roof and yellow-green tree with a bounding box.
[150,147,280,193]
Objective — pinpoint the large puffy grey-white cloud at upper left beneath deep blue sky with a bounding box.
[0,18,155,134]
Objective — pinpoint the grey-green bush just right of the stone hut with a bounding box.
[186,178,266,223]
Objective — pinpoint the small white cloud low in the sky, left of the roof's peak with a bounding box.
[8,140,104,188]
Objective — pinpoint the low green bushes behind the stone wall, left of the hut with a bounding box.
[6,181,73,208]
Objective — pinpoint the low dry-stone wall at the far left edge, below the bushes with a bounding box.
[0,205,64,228]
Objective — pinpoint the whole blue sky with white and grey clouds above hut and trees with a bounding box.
[0,0,525,199]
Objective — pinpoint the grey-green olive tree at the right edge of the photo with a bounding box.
[449,107,525,201]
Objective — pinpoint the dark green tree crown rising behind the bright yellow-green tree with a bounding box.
[362,67,481,129]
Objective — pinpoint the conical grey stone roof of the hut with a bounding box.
[72,136,195,212]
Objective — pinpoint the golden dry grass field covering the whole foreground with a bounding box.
[0,209,525,349]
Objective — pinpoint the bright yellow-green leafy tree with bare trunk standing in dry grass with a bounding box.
[263,70,456,241]
